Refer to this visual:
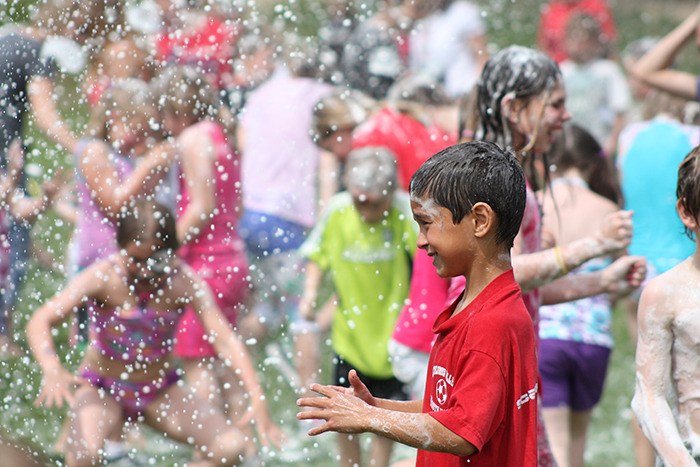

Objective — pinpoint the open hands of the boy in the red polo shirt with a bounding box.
[297,370,376,436]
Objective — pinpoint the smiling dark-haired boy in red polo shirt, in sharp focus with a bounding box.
[297,142,537,467]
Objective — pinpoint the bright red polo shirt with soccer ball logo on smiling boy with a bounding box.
[416,270,537,467]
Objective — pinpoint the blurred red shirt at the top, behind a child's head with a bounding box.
[537,0,616,63]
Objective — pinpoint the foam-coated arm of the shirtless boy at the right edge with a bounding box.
[632,282,696,467]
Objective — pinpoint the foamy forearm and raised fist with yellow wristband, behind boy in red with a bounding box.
[513,211,632,292]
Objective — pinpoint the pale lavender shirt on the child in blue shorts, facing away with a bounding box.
[241,68,330,228]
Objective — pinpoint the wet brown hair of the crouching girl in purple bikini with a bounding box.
[117,199,180,252]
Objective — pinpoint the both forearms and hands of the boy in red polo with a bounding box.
[297,370,476,456]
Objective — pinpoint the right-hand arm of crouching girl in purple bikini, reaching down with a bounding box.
[185,264,283,446]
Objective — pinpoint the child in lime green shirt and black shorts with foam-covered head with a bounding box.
[299,146,418,466]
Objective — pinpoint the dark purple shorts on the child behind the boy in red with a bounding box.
[539,339,610,412]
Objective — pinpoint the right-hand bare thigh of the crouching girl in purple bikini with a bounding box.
[144,385,247,466]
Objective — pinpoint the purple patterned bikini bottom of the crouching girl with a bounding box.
[80,369,180,420]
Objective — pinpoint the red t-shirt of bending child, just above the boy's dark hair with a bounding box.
[352,107,457,189]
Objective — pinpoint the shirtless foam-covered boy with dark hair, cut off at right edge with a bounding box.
[632,146,700,467]
